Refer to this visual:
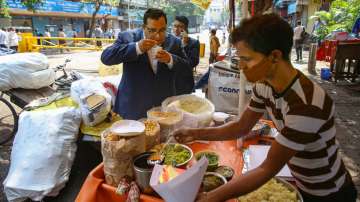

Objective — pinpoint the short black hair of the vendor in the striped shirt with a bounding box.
[230,14,294,61]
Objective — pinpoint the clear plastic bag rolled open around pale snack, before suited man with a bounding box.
[161,95,215,128]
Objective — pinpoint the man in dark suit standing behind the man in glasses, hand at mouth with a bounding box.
[173,16,200,95]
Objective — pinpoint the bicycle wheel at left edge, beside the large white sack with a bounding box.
[0,97,18,145]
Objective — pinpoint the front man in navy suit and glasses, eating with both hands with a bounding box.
[101,9,191,119]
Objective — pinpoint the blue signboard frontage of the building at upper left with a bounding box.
[7,0,123,37]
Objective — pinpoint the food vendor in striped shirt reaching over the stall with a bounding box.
[174,14,357,202]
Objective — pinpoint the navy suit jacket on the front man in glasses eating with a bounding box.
[101,29,191,119]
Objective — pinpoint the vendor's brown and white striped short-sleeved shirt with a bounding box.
[249,71,351,196]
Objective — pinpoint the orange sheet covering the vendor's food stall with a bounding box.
[76,141,244,202]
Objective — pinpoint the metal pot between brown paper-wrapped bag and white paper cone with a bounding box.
[133,152,154,194]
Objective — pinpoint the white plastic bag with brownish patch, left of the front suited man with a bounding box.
[71,79,111,126]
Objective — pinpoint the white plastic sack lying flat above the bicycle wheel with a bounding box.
[0,53,55,91]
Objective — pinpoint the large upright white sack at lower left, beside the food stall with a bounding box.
[3,107,81,202]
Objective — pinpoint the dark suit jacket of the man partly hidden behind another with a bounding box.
[175,38,200,95]
